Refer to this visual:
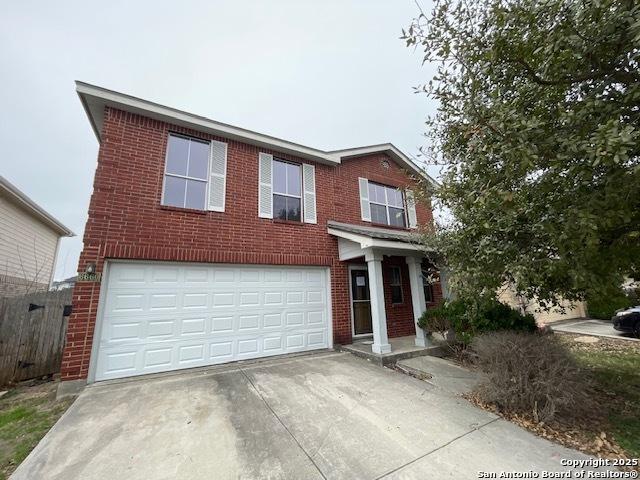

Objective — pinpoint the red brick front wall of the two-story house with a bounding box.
[62,108,438,380]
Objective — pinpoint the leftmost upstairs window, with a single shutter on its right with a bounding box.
[162,134,211,210]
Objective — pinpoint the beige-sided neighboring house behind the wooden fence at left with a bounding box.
[0,176,73,297]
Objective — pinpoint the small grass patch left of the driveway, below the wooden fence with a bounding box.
[0,381,72,480]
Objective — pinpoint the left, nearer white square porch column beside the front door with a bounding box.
[364,249,391,353]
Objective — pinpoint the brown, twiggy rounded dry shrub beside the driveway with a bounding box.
[471,332,596,422]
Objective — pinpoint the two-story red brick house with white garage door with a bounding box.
[62,82,442,382]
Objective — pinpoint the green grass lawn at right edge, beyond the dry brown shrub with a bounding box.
[571,341,640,458]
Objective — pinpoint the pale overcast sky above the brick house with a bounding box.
[0,0,438,279]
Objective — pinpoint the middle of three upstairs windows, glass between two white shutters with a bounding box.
[273,158,302,222]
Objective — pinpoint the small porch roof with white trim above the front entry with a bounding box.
[327,220,424,260]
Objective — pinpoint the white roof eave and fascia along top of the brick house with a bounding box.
[76,81,437,185]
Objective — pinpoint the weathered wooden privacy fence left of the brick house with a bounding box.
[0,288,73,386]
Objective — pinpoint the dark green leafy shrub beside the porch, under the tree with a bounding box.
[418,298,536,344]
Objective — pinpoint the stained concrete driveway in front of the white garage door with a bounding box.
[12,352,608,480]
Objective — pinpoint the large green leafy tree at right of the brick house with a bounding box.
[403,0,640,305]
